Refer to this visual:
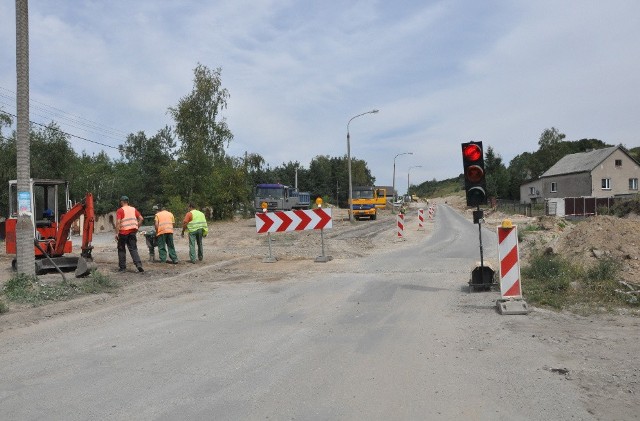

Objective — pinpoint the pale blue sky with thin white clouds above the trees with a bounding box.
[0,0,640,193]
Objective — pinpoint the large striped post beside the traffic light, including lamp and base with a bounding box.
[496,219,529,314]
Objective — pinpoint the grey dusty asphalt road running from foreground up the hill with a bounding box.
[0,206,595,420]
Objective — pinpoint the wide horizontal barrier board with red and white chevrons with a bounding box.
[256,208,333,234]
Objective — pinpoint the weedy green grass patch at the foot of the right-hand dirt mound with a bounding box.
[521,252,639,313]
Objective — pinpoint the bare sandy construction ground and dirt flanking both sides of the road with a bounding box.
[0,196,640,419]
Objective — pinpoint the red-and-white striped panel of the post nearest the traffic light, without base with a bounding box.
[498,224,522,299]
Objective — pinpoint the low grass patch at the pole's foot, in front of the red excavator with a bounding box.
[0,270,118,313]
